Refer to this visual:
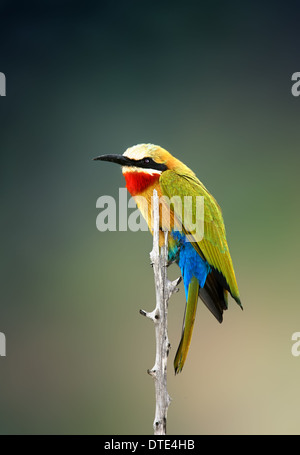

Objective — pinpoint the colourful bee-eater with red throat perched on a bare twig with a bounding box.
[94,143,243,374]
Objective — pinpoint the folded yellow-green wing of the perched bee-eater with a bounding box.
[159,170,241,304]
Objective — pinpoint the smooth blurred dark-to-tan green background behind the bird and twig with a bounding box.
[0,0,300,434]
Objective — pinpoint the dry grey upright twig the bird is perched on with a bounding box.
[140,190,181,435]
